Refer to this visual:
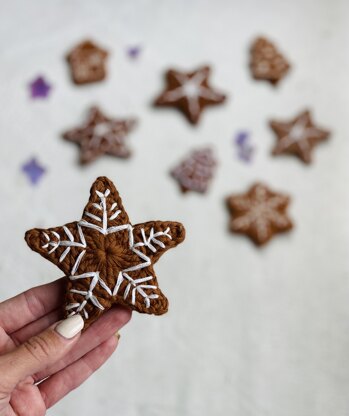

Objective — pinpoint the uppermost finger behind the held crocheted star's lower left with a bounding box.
[0,278,64,334]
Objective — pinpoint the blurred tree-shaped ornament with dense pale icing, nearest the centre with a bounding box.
[171,148,217,193]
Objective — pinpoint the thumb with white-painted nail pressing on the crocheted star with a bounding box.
[0,315,84,393]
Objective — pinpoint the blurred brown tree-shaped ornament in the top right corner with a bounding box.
[250,37,290,85]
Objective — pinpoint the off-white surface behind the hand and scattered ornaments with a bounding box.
[0,0,349,416]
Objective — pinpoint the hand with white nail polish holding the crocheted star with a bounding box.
[0,279,131,416]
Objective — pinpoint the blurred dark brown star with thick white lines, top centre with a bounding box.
[155,66,226,124]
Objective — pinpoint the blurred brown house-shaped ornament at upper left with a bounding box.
[67,40,108,84]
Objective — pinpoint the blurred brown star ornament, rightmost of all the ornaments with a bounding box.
[270,111,330,164]
